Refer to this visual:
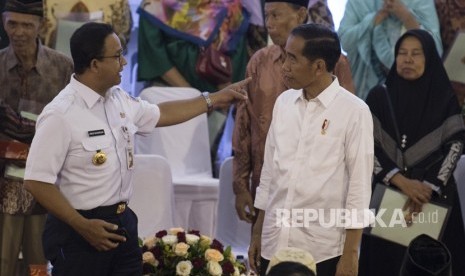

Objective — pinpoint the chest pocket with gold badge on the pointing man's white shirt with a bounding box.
[68,136,117,174]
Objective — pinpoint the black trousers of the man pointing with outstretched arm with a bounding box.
[42,207,142,276]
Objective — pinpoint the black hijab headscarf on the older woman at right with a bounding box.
[367,29,460,148]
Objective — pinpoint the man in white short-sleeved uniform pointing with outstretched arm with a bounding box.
[24,23,249,276]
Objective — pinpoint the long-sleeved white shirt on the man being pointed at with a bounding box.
[255,79,374,262]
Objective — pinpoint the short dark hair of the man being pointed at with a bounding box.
[291,23,341,72]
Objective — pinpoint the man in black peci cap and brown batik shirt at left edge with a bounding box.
[0,0,73,276]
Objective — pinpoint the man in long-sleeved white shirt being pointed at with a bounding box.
[249,24,374,276]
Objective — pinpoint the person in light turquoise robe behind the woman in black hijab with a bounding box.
[338,0,442,100]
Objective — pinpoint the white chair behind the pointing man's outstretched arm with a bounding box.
[135,87,219,235]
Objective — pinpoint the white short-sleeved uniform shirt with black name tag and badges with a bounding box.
[25,75,160,210]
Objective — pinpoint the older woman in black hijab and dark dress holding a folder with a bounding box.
[359,30,465,276]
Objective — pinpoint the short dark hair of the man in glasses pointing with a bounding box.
[69,22,115,74]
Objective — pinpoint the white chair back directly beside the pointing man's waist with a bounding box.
[129,154,174,238]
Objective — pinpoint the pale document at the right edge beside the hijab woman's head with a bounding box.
[444,32,465,83]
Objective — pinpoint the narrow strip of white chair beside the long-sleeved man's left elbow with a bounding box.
[216,157,252,259]
